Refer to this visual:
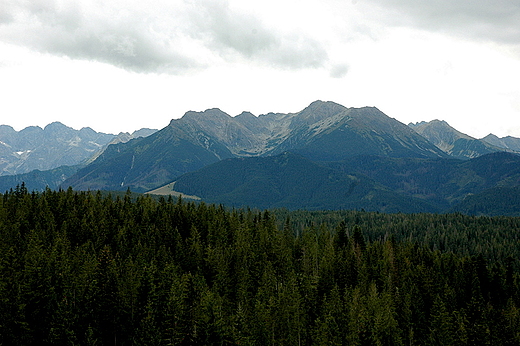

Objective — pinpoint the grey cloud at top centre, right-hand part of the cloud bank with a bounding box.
[185,1,328,69]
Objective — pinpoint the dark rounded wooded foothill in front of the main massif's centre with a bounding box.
[174,152,436,212]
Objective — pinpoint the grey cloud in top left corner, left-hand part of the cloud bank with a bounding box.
[0,0,207,73]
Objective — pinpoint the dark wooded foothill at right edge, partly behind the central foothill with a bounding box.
[328,152,520,210]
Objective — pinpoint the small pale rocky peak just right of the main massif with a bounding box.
[408,120,503,159]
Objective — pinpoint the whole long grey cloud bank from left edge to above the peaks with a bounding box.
[0,0,328,74]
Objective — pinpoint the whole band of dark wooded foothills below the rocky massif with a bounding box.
[174,152,520,215]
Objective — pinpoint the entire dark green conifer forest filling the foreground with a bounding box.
[0,186,520,345]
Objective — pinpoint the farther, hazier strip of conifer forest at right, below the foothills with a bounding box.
[272,209,520,261]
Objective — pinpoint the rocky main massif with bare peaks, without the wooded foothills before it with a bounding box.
[64,101,446,191]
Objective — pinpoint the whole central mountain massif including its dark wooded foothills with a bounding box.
[0,101,520,214]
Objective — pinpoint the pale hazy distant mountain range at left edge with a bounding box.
[0,122,157,191]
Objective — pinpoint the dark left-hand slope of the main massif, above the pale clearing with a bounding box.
[63,120,237,192]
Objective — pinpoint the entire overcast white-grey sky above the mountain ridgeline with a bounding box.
[0,0,520,138]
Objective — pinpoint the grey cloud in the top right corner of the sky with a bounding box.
[366,0,520,45]
